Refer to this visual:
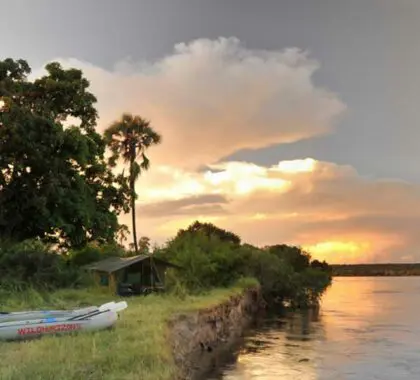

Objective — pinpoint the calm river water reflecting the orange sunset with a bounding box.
[208,277,420,380]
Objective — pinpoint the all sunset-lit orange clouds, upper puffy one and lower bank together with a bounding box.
[42,38,420,263]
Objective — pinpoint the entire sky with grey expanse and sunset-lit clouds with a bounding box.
[0,0,420,263]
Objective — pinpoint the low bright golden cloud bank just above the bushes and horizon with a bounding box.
[131,158,420,262]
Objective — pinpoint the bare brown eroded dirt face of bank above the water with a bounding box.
[169,288,264,380]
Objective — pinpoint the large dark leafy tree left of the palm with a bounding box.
[0,58,129,247]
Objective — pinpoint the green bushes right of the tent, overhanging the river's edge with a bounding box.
[156,222,331,306]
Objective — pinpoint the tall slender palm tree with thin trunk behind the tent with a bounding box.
[105,114,162,253]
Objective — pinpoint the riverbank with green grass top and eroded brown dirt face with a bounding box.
[0,285,256,380]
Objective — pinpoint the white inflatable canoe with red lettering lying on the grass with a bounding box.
[0,301,127,341]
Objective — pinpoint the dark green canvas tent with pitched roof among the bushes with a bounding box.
[84,255,178,294]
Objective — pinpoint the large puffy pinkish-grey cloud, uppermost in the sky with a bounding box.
[48,38,345,168]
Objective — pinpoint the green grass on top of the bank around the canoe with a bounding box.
[0,280,255,380]
